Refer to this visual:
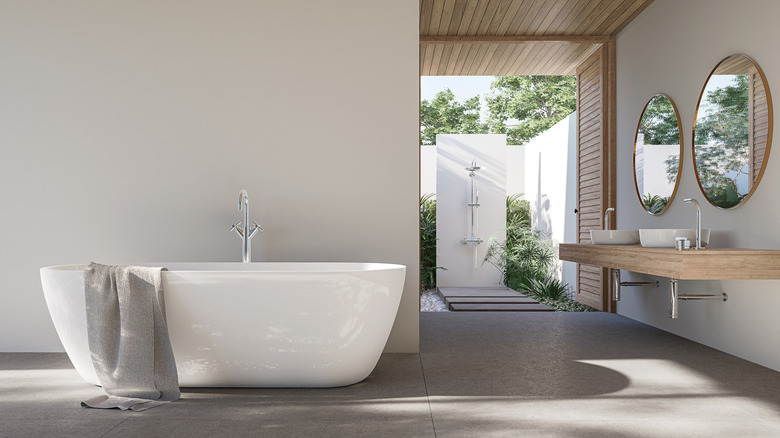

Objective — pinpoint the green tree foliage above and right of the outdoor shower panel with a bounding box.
[486,76,577,145]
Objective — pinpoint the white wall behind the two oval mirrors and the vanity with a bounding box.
[617,0,780,370]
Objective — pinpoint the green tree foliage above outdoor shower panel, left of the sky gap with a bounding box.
[420,89,488,145]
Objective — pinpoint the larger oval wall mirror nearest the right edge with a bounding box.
[693,55,772,208]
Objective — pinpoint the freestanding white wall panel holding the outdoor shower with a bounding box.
[436,134,506,287]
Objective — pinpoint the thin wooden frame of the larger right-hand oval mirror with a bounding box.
[691,53,774,210]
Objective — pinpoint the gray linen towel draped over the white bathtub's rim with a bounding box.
[81,262,181,411]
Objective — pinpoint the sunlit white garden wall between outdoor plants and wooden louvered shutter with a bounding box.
[524,112,577,288]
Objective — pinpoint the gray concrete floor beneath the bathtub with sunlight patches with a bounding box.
[0,312,780,438]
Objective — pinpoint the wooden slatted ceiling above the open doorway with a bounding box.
[420,0,653,76]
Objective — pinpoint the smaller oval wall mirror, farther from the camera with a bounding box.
[634,94,683,214]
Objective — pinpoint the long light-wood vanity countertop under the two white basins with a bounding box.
[558,243,780,280]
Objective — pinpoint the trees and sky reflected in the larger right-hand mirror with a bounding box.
[694,75,750,208]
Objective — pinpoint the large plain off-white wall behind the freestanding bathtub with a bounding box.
[0,0,419,352]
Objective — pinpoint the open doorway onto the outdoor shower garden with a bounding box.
[420,75,590,311]
